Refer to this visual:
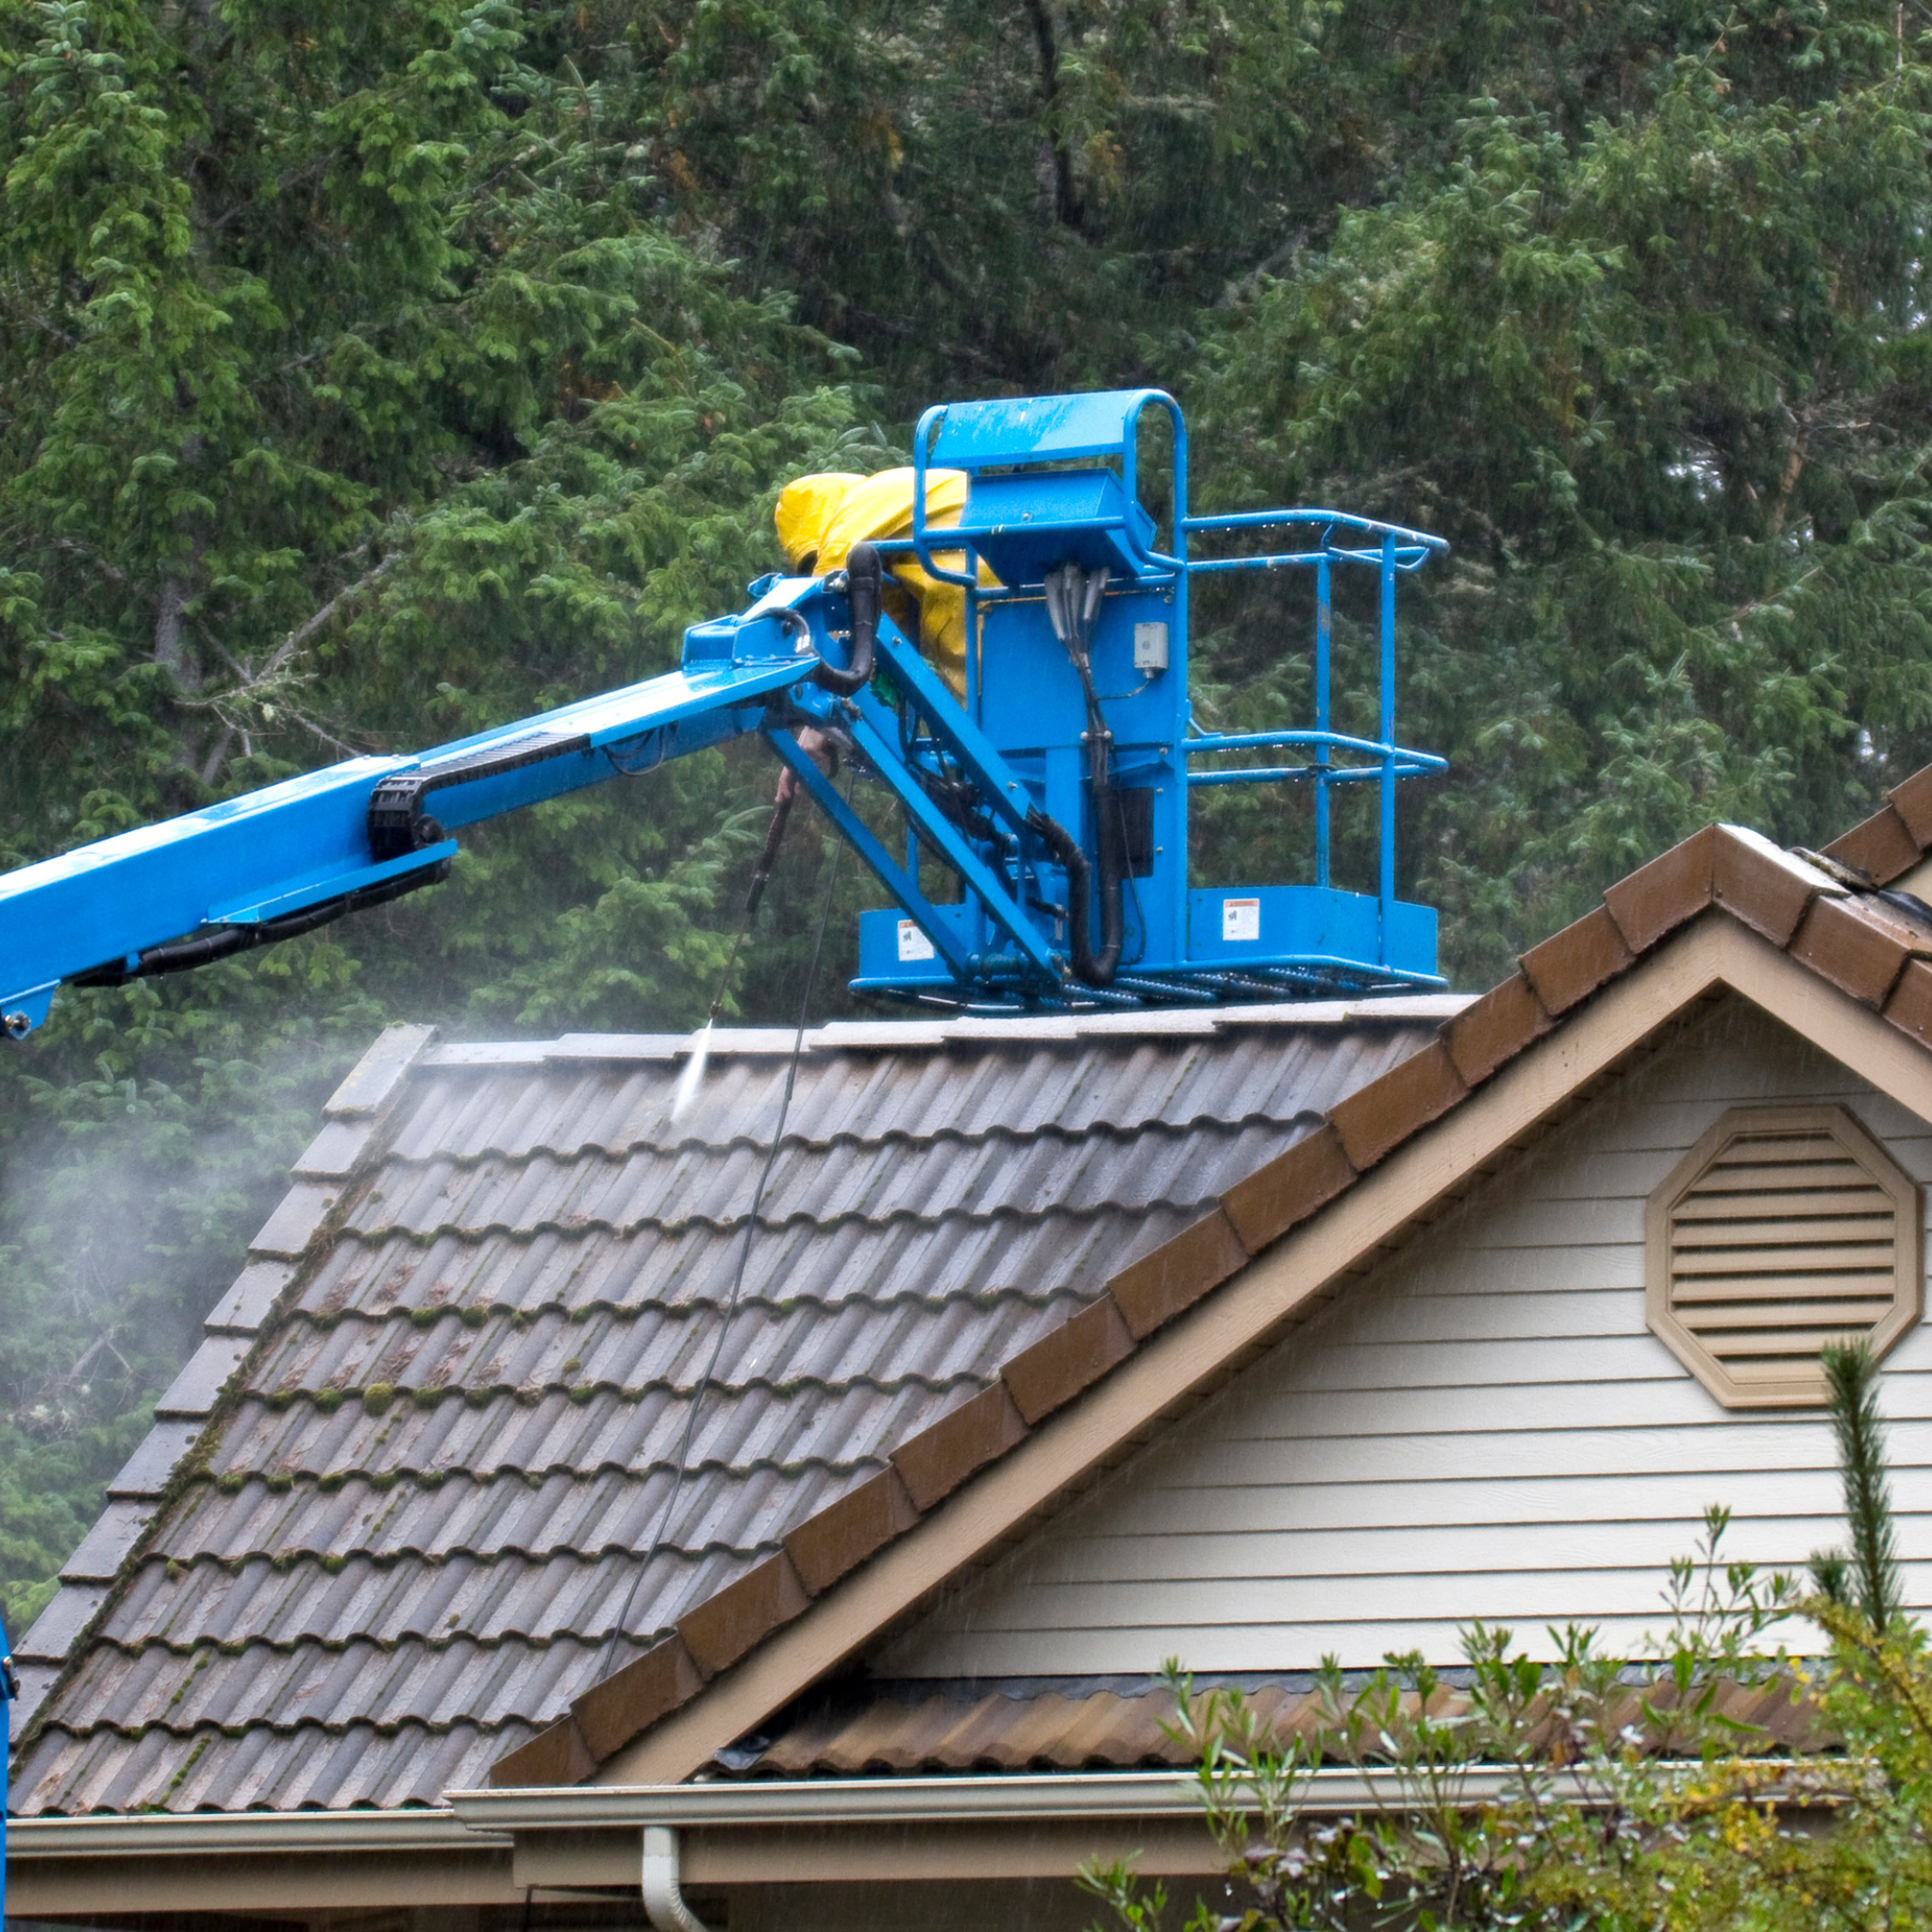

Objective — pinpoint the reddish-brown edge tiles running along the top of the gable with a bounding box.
[471,791,1932,1785]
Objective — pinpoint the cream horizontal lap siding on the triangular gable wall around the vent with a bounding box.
[870,999,1932,1677]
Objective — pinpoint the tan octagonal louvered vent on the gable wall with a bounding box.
[1644,1108,1923,1408]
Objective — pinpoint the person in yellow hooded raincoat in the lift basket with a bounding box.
[773,470,999,697]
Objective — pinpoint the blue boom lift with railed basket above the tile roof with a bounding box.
[0,391,1443,1040]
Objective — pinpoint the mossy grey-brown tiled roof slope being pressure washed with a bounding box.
[13,999,1462,1814]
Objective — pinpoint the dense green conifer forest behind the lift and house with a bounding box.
[0,0,1932,1635]
